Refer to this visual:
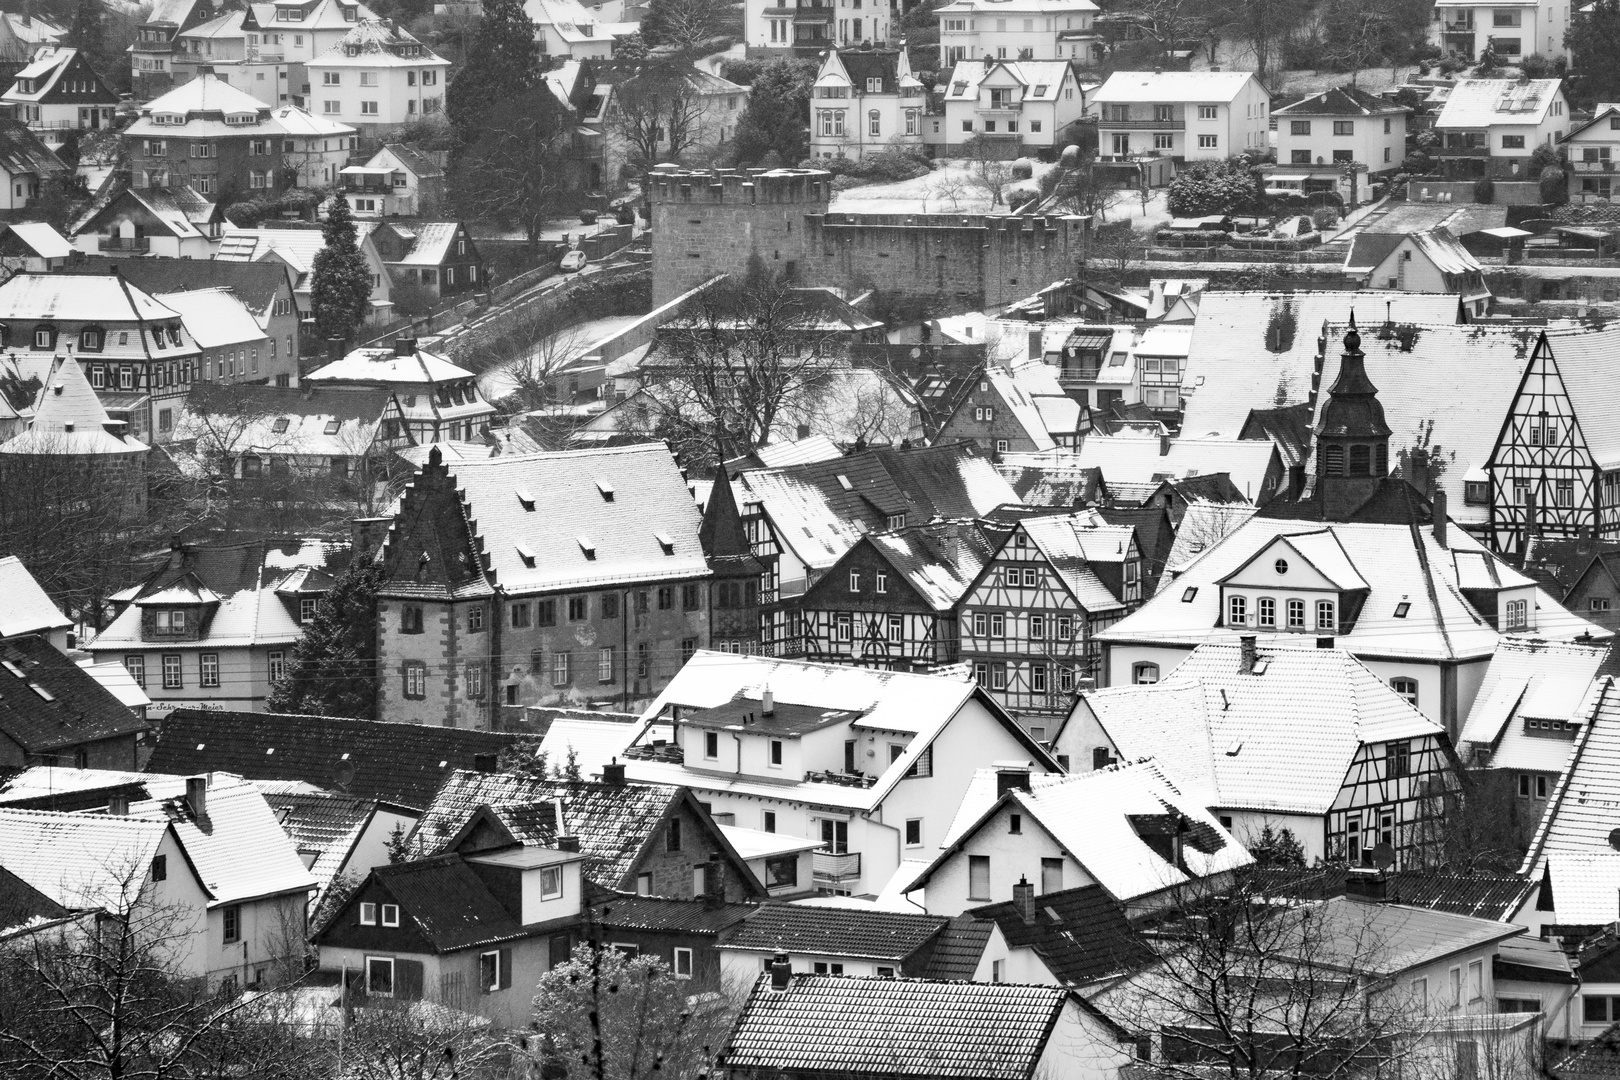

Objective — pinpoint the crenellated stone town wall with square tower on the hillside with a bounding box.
[650,168,1090,309]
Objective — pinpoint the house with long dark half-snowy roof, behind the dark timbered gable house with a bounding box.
[737,442,1019,656]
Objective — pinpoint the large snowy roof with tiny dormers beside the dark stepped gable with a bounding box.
[382,442,710,596]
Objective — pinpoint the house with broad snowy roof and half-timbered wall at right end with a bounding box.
[1053,636,1456,868]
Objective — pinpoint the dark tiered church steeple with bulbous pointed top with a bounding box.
[1315,311,1390,518]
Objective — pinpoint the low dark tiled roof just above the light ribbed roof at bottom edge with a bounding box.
[721,904,946,963]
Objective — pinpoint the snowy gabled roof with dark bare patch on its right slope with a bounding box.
[910,758,1254,902]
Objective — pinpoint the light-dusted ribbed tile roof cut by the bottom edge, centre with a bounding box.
[724,975,1071,1080]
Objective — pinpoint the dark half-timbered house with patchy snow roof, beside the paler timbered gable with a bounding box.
[797,521,993,672]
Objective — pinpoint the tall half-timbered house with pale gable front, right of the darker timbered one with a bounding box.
[959,510,1142,738]
